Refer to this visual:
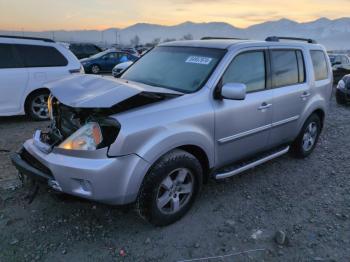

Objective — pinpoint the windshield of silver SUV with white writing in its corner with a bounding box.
[121,46,226,93]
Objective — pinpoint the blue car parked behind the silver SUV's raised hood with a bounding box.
[80,49,138,74]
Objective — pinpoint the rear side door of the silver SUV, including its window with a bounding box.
[269,49,311,147]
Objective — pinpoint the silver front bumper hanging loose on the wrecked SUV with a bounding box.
[11,139,149,205]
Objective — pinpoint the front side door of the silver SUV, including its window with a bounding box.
[214,49,273,166]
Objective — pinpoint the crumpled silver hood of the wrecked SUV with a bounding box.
[46,75,182,108]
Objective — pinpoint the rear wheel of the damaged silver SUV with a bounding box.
[291,114,322,158]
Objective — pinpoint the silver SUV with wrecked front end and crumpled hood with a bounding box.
[12,37,332,225]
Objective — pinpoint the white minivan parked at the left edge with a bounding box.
[0,36,81,120]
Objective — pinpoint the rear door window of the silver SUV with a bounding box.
[271,50,305,87]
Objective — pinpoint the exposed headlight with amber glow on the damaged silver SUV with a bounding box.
[58,122,103,150]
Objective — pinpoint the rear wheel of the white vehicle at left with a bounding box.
[25,90,50,121]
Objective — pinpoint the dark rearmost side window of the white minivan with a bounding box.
[14,45,68,67]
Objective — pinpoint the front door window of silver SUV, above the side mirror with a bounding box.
[222,51,266,92]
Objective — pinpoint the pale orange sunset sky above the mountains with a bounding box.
[0,0,350,31]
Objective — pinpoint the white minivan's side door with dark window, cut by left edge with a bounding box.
[0,44,28,115]
